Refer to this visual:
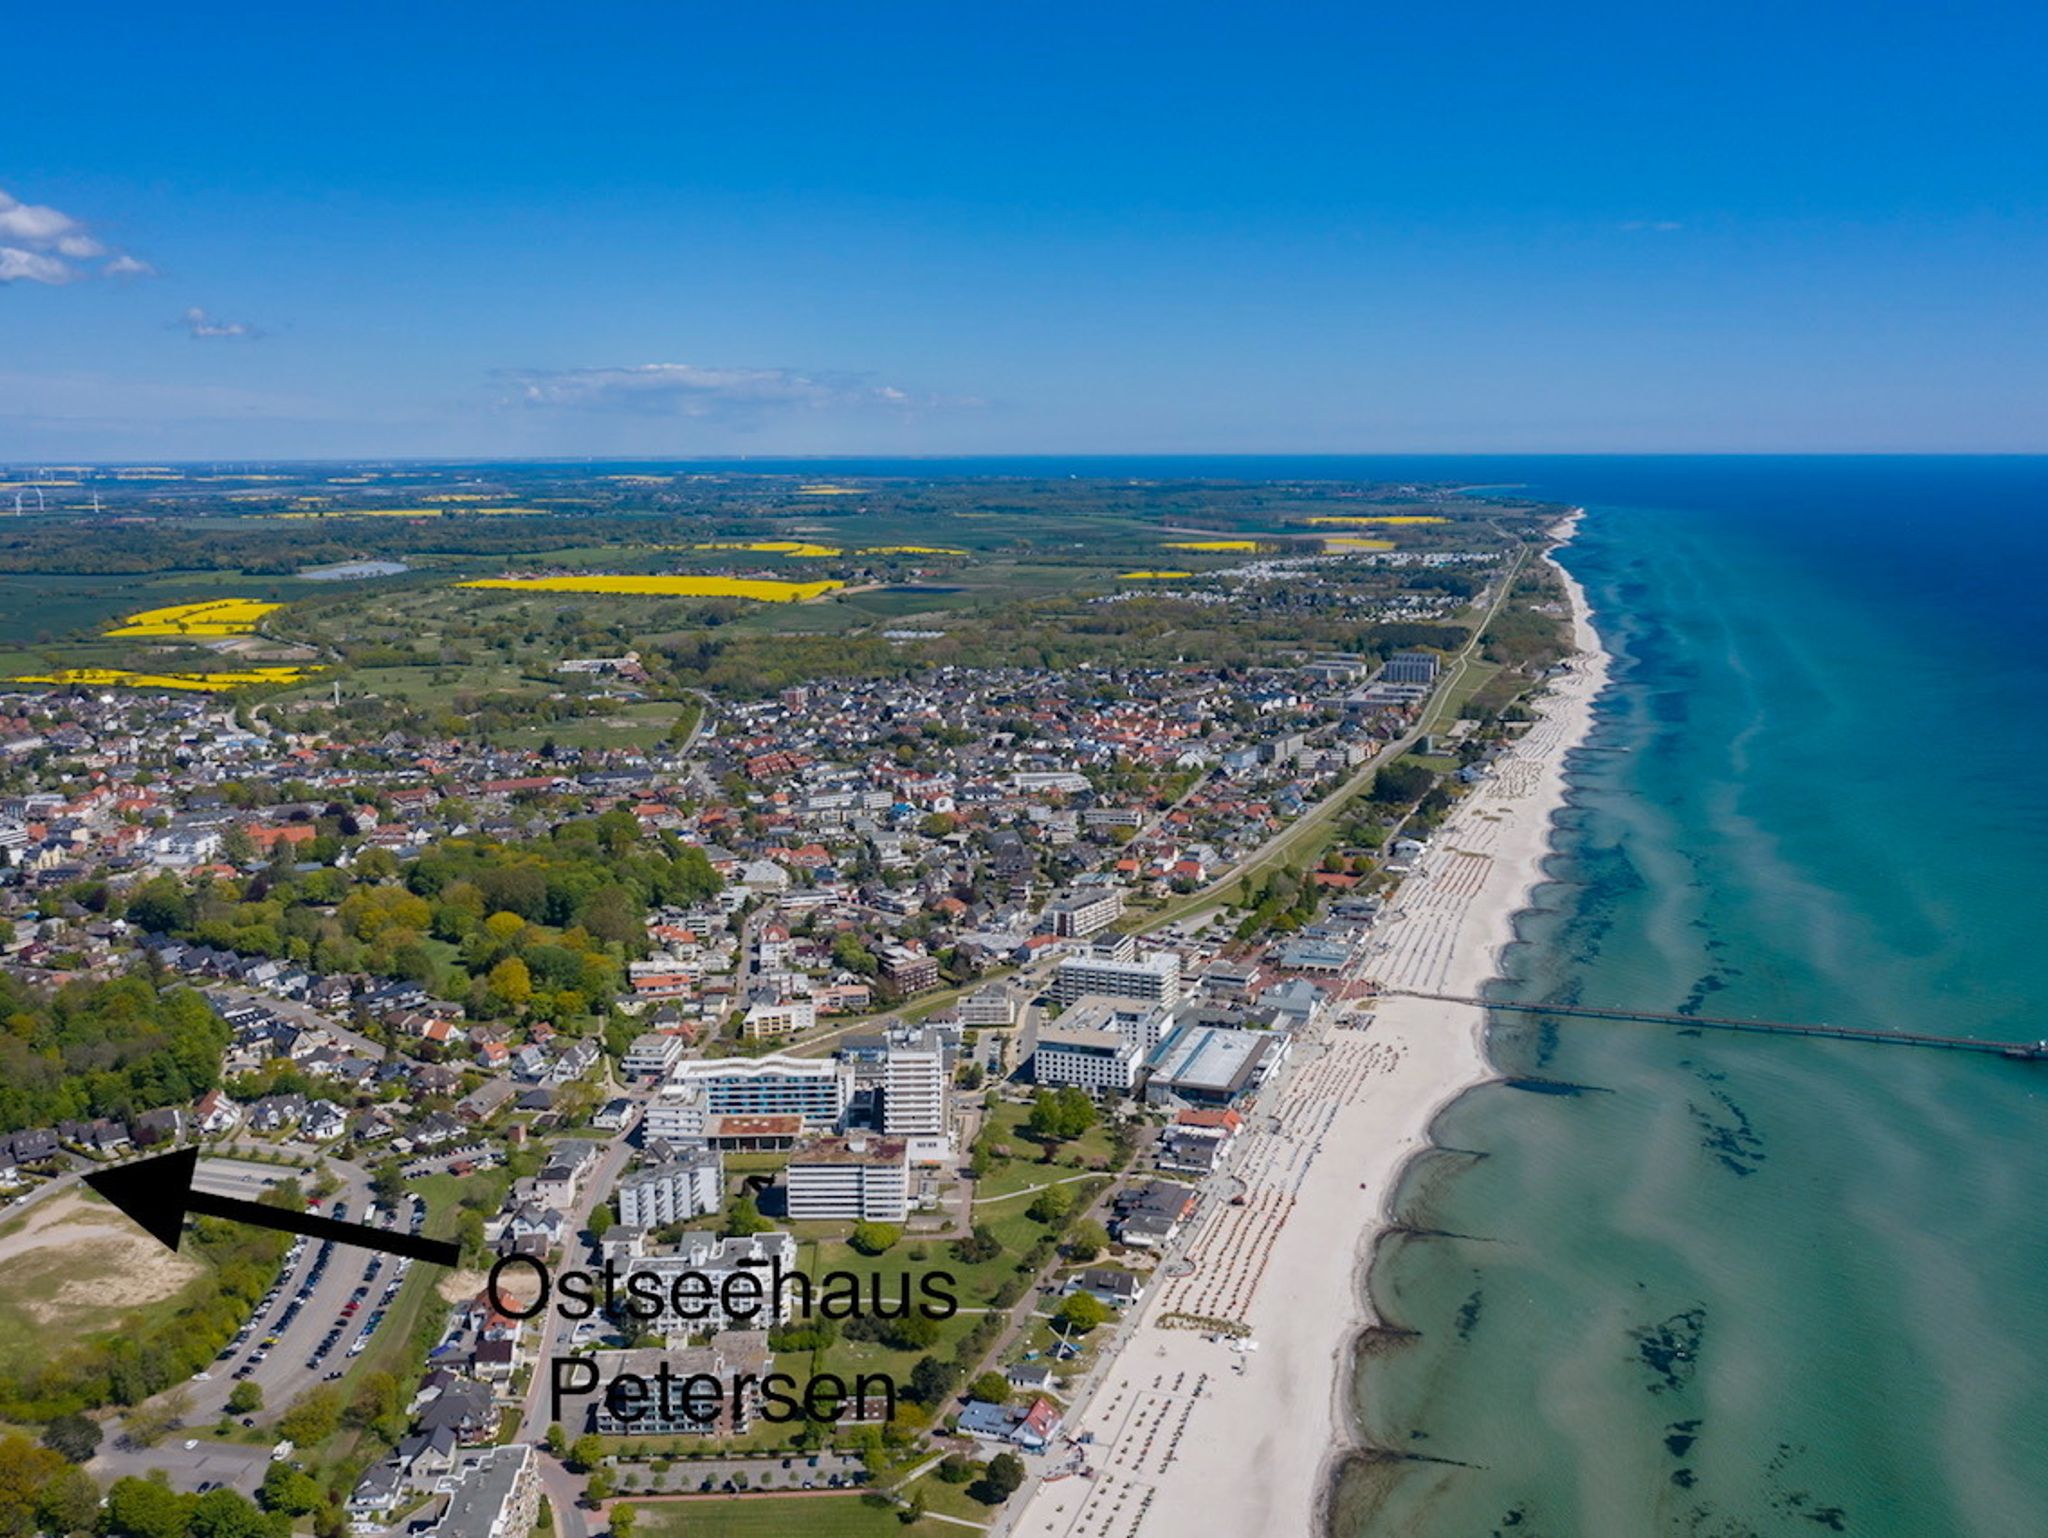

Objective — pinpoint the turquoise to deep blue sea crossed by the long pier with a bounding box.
[1333,461,2048,1538]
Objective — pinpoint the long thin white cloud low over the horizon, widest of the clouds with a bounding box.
[500,362,933,418]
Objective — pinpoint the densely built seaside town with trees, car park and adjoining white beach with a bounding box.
[0,475,1597,1538]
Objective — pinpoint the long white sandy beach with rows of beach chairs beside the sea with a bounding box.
[1008,528,1608,1538]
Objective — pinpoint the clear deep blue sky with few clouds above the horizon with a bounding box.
[0,0,2048,461]
